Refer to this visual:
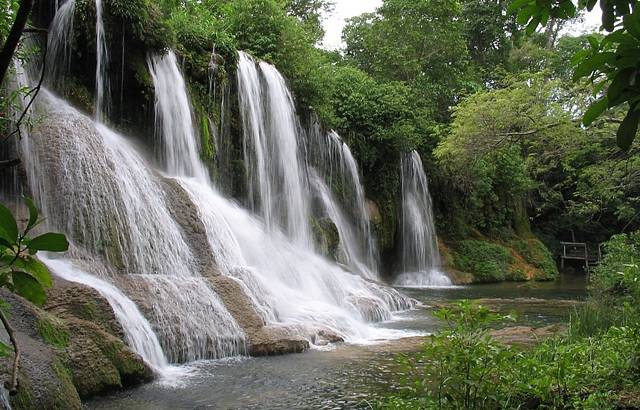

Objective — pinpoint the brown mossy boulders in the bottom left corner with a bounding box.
[0,279,153,409]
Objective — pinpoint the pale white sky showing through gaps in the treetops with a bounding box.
[322,0,600,50]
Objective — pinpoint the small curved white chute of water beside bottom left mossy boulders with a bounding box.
[40,256,169,373]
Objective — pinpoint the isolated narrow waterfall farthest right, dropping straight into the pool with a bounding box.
[396,151,451,286]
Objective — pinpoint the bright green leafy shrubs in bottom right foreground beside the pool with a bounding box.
[377,302,640,409]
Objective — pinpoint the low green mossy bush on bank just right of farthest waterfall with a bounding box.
[453,239,513,282]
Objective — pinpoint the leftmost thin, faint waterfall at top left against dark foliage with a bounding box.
[46,0,76,85]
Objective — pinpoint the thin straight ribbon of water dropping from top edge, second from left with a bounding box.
[95,0,111,122]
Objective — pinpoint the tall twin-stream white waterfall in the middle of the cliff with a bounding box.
[238,52,312,243]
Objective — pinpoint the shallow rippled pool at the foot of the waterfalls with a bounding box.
[85,276,586,410]
